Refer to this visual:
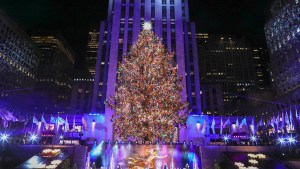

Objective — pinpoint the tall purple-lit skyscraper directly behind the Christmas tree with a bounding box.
[92,0,201,140]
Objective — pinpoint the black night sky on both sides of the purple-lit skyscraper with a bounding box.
[0,0,270,67]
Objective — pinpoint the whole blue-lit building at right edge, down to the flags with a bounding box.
[256,0,300,133]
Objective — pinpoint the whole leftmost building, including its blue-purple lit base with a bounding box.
[0,11,40,113]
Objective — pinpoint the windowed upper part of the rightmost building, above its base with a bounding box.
[265,0,300,95]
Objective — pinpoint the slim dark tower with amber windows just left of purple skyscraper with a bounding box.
[86,29,99,77]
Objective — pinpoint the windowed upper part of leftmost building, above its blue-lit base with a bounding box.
[0,11,39,95]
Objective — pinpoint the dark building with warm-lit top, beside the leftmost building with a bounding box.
[31,34,75,113]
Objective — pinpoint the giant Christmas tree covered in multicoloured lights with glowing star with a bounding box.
[107,23,188,141]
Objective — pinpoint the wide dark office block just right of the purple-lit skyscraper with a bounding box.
[197,33,256,113]
